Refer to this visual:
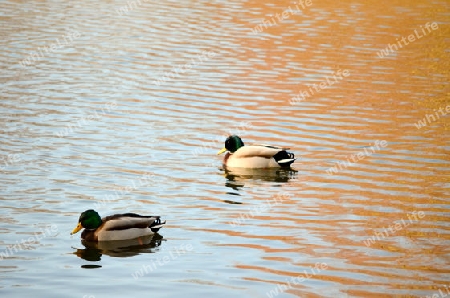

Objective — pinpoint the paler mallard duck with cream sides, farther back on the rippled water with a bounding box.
[217,135,296,168]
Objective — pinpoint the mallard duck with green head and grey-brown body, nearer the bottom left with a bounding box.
[70,209,166,242]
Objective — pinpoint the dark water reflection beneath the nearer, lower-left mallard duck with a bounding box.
[73,233,163,267]
